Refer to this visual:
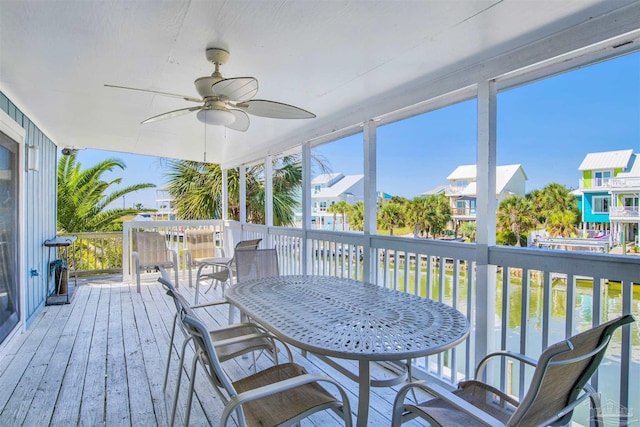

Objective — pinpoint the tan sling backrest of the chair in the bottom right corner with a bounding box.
[507,314,634,426]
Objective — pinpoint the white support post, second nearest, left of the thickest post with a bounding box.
[363,120,378,283]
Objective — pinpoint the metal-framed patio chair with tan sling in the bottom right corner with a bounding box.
[392,315,634,427]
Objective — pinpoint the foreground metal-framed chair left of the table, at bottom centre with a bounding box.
[181,311,351,427]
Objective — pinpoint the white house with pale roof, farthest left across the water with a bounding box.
[311,172,364,230]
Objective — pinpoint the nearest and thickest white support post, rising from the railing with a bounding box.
[472,81,497,372]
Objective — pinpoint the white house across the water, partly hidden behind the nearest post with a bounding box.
[444,165,527,224]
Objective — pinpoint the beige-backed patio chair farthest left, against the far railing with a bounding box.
[132,231,179,292]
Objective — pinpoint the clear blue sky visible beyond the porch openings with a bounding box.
[78,52,640,207]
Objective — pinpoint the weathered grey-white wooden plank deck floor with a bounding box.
[0,276,430,426]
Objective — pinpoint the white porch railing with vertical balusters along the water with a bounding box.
[124,221,640,425]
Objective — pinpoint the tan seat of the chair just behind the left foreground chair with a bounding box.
[209,323,273,362]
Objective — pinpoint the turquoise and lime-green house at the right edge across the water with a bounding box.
[574,149,640,245]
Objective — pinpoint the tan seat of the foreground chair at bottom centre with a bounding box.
[233,363,342,427]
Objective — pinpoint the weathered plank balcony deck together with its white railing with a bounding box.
[6,221,640,425]
